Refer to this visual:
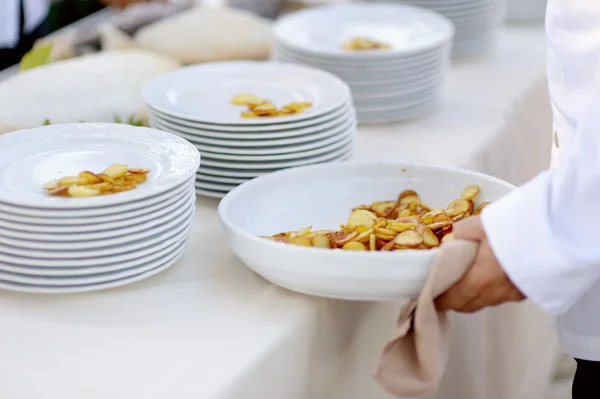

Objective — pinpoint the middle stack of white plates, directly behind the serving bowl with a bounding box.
[144,61,356,198]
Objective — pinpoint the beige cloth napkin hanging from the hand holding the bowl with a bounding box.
[375,240,477,397]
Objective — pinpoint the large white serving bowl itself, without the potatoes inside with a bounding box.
[219,162,514,300]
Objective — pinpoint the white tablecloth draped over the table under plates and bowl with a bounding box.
[0,28,556,399]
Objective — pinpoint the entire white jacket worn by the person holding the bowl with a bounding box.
[482,0,600,361]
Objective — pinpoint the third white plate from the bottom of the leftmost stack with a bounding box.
[0,223,191,270]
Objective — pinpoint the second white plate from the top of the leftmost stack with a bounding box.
[0,179,193,226]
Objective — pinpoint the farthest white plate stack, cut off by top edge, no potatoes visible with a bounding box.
[375,0,506,59]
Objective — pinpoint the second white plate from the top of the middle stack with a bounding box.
[150,97,352,134]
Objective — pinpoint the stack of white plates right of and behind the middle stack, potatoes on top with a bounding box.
[273,3,454,123]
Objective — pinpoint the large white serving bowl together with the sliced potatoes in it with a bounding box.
[219,162,515,301]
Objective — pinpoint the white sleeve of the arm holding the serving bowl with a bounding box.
[482,74,600,315]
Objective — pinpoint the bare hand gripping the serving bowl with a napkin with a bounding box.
[435,216,525,313]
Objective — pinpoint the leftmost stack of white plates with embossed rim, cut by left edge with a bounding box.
[0,124,200,293]
